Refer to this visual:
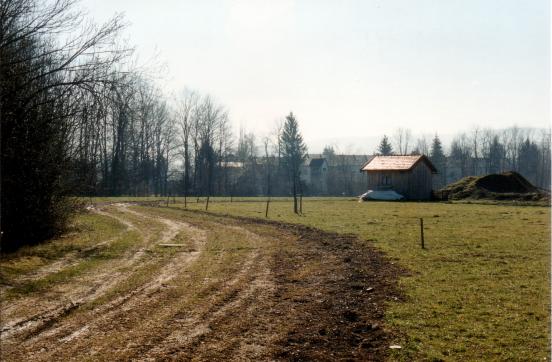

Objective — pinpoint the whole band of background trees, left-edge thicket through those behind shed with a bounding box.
[0,0,550,249]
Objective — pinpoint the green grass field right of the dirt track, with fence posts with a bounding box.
[97,198,550,360]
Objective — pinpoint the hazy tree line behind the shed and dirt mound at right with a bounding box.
[377,126,551,190]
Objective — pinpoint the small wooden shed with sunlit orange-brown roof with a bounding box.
[360,155,437,200]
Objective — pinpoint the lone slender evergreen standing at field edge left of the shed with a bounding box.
[281,112,307,214]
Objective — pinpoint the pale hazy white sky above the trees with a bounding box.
[81,0,550,152]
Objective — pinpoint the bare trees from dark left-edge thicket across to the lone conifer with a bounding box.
[0,0,306,250]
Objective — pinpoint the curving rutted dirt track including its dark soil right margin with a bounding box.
[1,204,401,361]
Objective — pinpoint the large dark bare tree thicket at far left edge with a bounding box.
[0,0,129,248]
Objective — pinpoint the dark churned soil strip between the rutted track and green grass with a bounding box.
[216,218,406,361]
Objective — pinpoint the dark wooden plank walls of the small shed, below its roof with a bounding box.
[368,162,433,200]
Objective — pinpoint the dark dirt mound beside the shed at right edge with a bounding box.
[436,171,550,201]
